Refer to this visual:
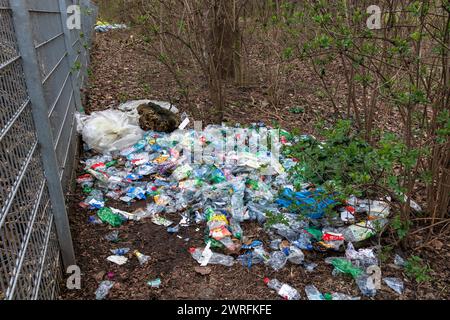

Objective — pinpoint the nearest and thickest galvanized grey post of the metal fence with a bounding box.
[10,0,75,267]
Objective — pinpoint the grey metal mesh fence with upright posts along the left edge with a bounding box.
[0,0,97,299]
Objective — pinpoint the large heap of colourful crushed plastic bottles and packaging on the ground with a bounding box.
[77,105,403,300]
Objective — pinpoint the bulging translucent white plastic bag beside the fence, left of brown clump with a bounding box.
[76,109,144,153]
